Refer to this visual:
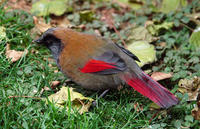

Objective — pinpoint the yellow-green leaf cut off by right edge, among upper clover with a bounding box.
[189,27,200,48]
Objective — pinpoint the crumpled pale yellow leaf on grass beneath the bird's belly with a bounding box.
[46,86,93,114]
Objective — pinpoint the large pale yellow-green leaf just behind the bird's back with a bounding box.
[127,41,156,67]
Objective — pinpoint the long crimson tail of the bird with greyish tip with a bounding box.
[123,73,178,108]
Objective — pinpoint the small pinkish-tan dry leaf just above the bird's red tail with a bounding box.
[151,72,172,81]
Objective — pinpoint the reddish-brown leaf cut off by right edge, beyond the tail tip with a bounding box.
[192,92,200,120]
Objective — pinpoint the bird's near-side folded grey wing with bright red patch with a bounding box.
[80,51,127,75]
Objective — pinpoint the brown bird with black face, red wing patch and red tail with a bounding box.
[34,27,179,108]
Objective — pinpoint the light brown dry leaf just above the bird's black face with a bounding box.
[33,16,52,34]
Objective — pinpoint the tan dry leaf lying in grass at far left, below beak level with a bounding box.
[6,44,28,62]
